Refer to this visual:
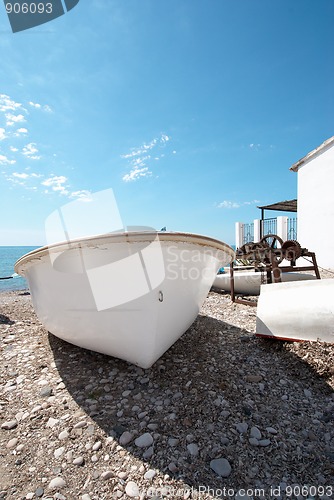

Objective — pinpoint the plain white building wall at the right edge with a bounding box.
[297,144,334,269]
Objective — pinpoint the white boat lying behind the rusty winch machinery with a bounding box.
[212,269,317,295]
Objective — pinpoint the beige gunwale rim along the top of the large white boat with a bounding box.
[14,231,235,274]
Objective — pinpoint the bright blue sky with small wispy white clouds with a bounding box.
[0,0,334,245]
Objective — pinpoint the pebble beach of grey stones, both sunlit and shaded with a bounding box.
[0,275,334,500]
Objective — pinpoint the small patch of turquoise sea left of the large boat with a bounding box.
[0,246,38,293]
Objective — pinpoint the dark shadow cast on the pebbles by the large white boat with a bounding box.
[49,315,333,489]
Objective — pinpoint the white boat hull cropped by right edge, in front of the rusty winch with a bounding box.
[256,279,334,342]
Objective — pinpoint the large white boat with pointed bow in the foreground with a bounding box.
[15,231,234,368]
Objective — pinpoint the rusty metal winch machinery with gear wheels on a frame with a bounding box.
[230,234,320,305]
